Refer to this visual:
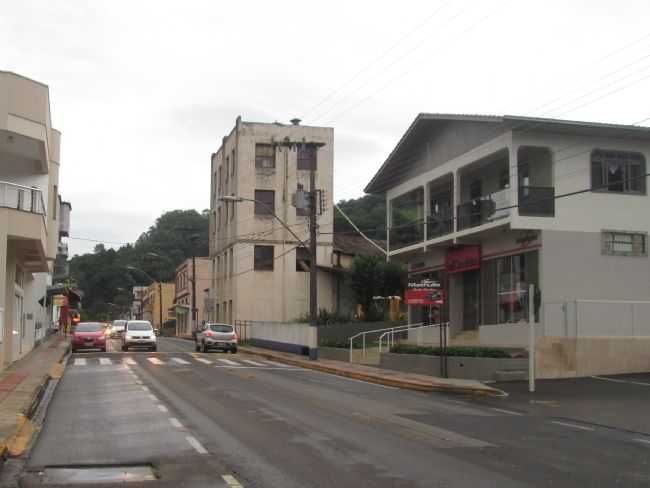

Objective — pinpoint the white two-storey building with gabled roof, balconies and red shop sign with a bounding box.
[366,114,650,376]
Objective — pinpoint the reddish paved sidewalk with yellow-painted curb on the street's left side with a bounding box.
[0,334,69,458]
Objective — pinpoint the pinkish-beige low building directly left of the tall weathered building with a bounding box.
[173,257,210,335]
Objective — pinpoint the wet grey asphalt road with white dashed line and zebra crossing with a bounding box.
[17,338,650,488]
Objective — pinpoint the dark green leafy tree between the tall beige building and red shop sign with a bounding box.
[348,256,407,320]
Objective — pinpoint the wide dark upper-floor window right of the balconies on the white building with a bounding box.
[591,150,646,194]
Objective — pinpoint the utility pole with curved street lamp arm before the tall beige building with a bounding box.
[219,193,318,359]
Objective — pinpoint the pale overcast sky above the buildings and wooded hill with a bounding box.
[0,0,650,255]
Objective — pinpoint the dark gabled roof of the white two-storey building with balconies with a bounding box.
[364,113,650,193]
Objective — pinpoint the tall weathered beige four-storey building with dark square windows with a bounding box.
[206,118,336,323]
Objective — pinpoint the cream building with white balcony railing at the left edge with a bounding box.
[0,71,66,367]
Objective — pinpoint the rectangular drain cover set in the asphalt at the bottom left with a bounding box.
[42,466,156,486]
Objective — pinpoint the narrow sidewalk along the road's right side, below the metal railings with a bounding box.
[239,346,504,397]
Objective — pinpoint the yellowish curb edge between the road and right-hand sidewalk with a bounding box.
[239,346,505,397]
